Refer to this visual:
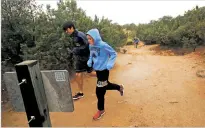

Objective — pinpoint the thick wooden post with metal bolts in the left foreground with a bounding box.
[15,60,51,127]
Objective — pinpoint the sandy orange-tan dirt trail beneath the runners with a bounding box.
[2,46,205,127]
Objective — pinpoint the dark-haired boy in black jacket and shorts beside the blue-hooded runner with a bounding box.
[63,21,95,100]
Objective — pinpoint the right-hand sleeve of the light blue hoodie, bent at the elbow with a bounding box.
[105,44,117,70]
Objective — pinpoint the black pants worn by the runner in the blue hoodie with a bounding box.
[96,70,120,111]
